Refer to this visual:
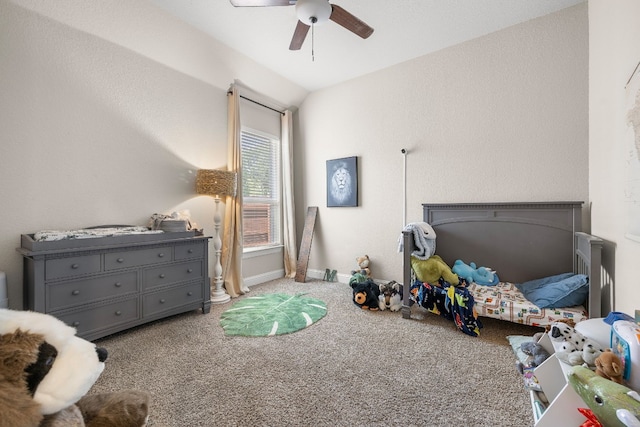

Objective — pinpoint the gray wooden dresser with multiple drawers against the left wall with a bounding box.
[18,232,211,340]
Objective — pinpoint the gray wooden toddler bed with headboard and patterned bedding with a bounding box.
[402,202,603,335]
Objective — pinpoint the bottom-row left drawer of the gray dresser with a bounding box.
[54,297,140,335]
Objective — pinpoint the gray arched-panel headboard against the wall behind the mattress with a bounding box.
[422,202,582,283]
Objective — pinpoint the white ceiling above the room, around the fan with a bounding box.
[151,0,586,91]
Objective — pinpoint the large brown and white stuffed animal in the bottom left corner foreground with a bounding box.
[0,309,149,427]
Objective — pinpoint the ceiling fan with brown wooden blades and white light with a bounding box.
[229,0,373,50]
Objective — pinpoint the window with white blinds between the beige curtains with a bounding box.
[241,130,282,249]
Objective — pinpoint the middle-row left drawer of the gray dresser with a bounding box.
[47,271,138,312]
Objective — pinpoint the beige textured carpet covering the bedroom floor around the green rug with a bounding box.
[90,279,539,427]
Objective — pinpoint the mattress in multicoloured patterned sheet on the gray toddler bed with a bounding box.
[467,282,589,327]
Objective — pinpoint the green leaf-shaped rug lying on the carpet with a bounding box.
[220,294,327,337]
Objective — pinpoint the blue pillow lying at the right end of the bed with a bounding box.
[516,273,589,308]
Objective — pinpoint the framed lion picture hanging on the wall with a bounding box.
[327,156,358,207]
